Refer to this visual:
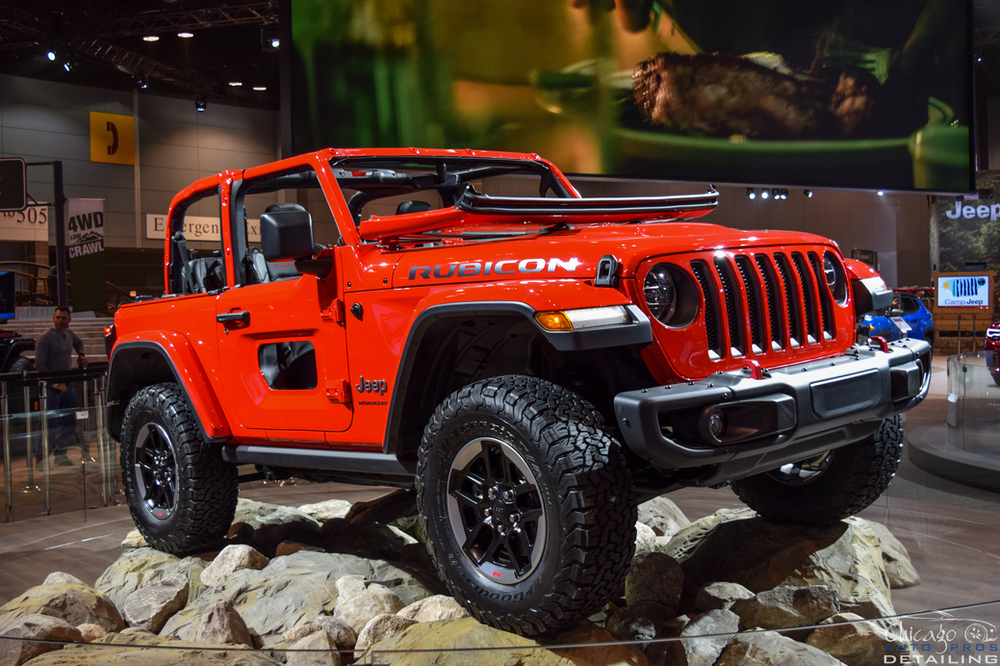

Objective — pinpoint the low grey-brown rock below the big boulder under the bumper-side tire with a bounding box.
[731,585,840,629]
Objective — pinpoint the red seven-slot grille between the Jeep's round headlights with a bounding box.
[691,251,837,359]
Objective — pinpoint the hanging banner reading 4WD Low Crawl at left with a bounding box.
[66,199,108,312]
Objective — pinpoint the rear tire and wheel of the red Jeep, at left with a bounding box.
[121,384,239,553]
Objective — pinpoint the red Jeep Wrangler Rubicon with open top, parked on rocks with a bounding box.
[108,149,930,634]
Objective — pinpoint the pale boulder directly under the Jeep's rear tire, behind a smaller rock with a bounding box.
[94,548,208,607]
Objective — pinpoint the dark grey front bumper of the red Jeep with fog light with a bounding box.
[614,339,931,478]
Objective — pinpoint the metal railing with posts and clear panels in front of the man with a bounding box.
[0,363,120,522]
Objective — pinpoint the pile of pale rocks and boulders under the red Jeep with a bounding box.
[0,491,920,666]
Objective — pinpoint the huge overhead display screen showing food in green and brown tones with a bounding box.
[285,0,974,193]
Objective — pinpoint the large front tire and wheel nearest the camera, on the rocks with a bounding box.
[416,375,636,635]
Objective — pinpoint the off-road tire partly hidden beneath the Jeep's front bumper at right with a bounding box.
[732,415,903,525]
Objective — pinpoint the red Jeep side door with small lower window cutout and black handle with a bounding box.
[216,175,353,440]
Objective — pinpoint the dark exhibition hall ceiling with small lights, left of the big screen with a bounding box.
[0,0,280,110]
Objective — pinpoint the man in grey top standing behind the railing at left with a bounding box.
[35,305,87,467]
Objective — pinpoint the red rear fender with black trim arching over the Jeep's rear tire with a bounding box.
[108,331,232,441]
